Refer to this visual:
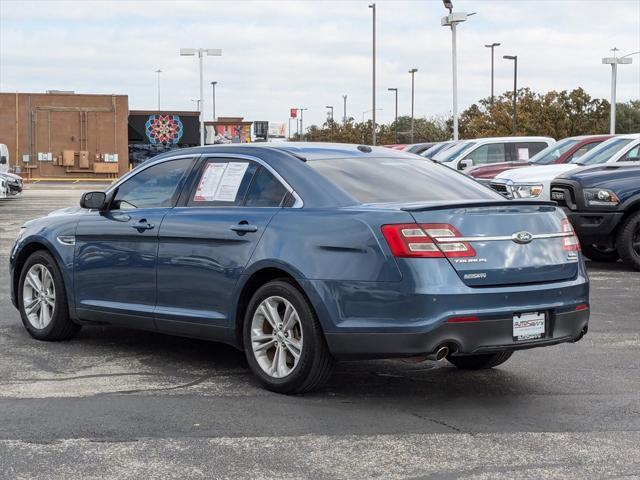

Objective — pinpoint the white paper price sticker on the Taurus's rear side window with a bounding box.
[193,162,249,202]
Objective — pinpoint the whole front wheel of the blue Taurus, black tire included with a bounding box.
[17,250,80,341]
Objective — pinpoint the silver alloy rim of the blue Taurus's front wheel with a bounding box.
[22,263,56,330]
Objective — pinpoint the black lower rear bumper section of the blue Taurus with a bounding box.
[326,310,589,359]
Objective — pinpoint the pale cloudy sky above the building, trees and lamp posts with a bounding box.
[0,0,640,126]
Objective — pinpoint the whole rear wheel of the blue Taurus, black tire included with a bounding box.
[243,279,334,394]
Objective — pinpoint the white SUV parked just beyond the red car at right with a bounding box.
[433,137,556,170]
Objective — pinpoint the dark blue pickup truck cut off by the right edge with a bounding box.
[551,163,640,270]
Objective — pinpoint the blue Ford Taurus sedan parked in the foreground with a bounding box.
[11,144,589,393]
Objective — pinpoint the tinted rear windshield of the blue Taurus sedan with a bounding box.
[307,158,504,203]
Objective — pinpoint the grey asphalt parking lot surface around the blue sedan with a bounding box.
[0,185,640,479]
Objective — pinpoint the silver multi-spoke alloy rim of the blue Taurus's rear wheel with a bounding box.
[251,296,303,378]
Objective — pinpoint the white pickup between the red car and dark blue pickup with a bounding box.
[490,133,640,200]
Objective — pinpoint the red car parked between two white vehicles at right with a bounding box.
[464,135,611,180]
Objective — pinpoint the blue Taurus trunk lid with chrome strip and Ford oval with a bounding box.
[402,200,579,287]
